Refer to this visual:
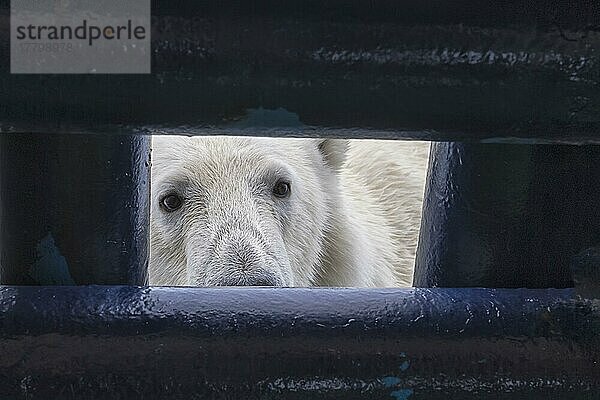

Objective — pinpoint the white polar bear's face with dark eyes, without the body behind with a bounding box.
[150,136,343,286]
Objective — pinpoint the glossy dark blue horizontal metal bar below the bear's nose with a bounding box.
[0,286,600,399]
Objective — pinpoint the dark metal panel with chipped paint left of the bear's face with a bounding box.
[0,134,150,285]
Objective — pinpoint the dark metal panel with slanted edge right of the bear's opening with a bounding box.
[414,142,600,288]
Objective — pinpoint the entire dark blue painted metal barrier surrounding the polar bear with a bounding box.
[0,0,600,400]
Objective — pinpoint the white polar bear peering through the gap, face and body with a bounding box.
[149,136,429,287]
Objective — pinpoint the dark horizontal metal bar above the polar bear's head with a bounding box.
[0,0,600,142]
